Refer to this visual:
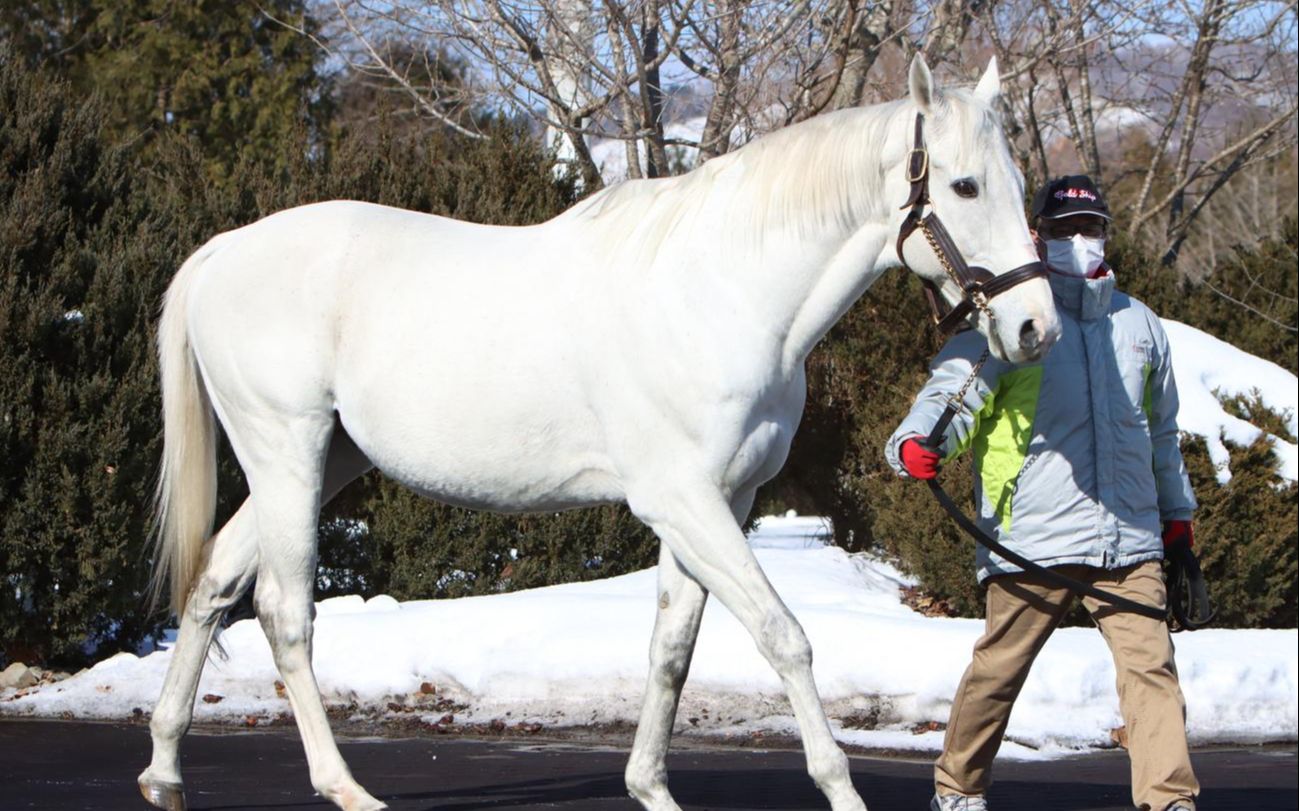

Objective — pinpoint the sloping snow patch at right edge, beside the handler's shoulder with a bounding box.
[1163,318,1299,483]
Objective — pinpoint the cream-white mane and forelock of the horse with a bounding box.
[559,90,999,265]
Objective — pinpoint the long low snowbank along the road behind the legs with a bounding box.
[0,517,1299,758]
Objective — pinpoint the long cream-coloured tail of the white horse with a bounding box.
[149,239,217,616]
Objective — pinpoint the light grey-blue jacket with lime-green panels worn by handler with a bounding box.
[885,273,1196,582]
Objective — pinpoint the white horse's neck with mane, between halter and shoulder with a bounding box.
[564,102,900,373]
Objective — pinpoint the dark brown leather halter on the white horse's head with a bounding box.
[896,113,1047,334]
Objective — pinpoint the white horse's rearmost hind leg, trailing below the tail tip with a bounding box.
[139,430,372,811]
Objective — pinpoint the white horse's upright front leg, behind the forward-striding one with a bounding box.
[626,490,753,811]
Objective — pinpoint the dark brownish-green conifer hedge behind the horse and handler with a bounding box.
[0,44,1296,664]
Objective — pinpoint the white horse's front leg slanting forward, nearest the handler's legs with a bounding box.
[629,476,866,811]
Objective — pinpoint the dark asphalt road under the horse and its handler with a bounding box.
[0,720,1299,811]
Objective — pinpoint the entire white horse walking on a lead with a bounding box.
[139,58,1059,811]
